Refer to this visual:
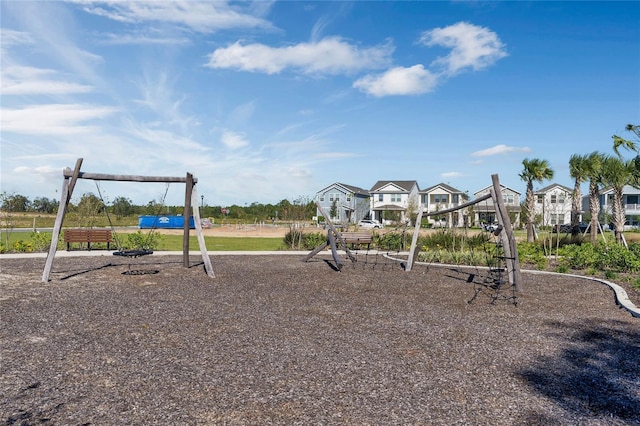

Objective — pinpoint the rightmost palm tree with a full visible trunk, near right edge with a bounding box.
[602,156,635,243]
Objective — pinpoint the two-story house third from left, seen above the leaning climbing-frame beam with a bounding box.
[420,183,469,228]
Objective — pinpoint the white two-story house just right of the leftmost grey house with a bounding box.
[369,180,420,224]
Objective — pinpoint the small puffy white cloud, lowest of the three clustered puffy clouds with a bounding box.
[353,64,437,97]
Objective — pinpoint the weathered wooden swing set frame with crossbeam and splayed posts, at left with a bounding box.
[42,158,215,282]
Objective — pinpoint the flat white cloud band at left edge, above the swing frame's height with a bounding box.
[0,104,117,135]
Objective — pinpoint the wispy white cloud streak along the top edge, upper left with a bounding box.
[75,0,272,33]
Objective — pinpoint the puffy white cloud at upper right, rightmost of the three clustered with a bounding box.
[419,22,507,74]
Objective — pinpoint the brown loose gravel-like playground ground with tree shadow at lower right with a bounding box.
[0,255,640,425]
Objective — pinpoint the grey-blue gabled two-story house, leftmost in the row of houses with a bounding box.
[316,182,370,224]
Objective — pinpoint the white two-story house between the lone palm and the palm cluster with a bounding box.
[533,183,582,226]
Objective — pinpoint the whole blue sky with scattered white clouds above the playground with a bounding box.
[0,1,640,205]
